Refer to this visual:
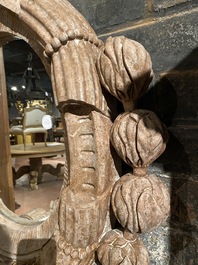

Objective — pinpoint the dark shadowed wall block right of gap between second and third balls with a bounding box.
[151,125,198,177]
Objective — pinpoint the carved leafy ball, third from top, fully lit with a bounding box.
[111,173,170,233]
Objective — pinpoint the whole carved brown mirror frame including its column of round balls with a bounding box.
[0,0,169,265]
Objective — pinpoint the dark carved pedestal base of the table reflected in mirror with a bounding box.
[12,157,64,190]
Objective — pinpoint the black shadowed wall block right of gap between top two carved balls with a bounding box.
[139,71,198,126]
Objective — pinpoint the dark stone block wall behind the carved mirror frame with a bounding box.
[70,0,198,265]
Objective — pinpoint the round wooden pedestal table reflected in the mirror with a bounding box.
[10,142,65,190]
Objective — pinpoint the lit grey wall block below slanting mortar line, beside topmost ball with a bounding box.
[100,11,198,74]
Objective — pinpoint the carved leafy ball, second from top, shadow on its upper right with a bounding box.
[111,109,168,167]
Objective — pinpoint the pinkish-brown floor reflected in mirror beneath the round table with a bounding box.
[12,156,65,215]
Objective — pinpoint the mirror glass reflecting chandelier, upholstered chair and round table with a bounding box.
[3,40,65,219]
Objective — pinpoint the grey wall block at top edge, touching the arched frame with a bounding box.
[69,0,146,34]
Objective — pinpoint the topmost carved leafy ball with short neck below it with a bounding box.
[97,36,153,110]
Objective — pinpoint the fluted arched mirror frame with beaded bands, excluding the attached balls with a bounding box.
[0,0,117,264]
